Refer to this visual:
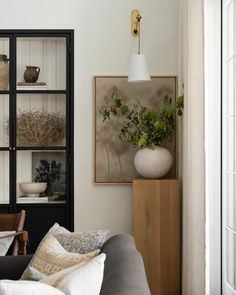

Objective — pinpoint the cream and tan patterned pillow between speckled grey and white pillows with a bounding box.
[21,234,99,280]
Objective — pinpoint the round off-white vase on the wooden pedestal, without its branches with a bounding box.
[134,146,172,178]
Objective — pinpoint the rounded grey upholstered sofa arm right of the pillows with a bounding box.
[100,235,151,295]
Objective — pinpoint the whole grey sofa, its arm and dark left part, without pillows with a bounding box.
[0,235,151,295]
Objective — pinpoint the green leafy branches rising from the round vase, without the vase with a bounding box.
[100,95,184,149]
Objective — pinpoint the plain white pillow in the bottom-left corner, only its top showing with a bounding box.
[0,280,65,295]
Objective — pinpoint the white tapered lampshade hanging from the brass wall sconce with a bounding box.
[128,54,151,82]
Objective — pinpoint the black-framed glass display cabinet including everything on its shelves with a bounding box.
[0,30,74,252]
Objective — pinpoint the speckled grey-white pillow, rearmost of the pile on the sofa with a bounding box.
[49,223,109,254]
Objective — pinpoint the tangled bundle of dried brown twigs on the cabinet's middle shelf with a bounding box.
[16,110,65,146]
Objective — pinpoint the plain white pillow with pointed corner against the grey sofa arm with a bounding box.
[41,253,106,295]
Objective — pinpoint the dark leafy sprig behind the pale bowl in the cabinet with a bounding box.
[34,160,62,196]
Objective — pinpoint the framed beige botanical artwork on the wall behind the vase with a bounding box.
[94,76,177,184]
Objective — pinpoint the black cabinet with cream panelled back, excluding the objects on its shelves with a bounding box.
[0,30,74,253]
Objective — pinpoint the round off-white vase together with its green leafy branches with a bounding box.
[100,95,184,178]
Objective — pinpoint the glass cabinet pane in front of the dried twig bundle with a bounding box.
[16,93,66,147]
